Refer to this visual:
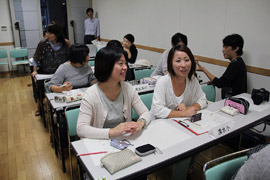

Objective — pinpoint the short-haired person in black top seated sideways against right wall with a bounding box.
[196,34,247,98]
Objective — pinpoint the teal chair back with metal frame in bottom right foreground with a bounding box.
[203,149,249,180]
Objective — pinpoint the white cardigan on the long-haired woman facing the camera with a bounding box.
[151,74,207,119]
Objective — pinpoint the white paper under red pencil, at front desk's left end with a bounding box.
[82,139,119,166]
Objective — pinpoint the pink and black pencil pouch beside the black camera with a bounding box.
[224,97,249,114]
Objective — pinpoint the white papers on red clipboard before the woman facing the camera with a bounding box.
[173,110,233,135]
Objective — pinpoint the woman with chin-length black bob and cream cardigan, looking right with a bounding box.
[77,47,151,139]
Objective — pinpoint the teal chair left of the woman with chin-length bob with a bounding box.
[65,105,80,179]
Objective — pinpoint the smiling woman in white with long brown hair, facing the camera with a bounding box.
[151,45,207,119]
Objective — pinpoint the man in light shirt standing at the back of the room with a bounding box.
[84,8,100,44]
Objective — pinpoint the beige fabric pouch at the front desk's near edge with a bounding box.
[100,148,142,174]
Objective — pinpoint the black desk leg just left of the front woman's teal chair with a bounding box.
[56,111,66,173]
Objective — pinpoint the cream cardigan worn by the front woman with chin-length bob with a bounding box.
[77,82,151,139]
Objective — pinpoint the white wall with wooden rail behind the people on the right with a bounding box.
[92,0,270,101]
